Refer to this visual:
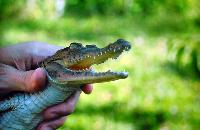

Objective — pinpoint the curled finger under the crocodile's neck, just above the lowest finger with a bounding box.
[43,91,81,120]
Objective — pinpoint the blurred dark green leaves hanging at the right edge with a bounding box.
[167,36,200,76]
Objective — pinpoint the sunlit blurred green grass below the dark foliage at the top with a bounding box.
[1,16,200,130]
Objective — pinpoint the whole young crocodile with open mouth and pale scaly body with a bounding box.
[0,39,131,130]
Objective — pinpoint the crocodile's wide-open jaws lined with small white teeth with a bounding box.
[46,39,131,84]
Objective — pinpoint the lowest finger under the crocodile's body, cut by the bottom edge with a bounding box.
[37,117,67,130]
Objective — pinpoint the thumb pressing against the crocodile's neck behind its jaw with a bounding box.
[0,64,46,92]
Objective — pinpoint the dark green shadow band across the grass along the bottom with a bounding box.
[75,102,171,130]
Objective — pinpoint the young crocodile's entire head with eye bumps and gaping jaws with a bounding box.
[43,39,131,84]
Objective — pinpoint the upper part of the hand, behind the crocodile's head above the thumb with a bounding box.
[0,41,62,70]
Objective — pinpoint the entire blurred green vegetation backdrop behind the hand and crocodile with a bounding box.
[0,0,200,130]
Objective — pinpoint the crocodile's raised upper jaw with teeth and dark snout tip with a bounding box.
[68,39,131,69]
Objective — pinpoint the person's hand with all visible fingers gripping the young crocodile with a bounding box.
[0,42,93,130]
